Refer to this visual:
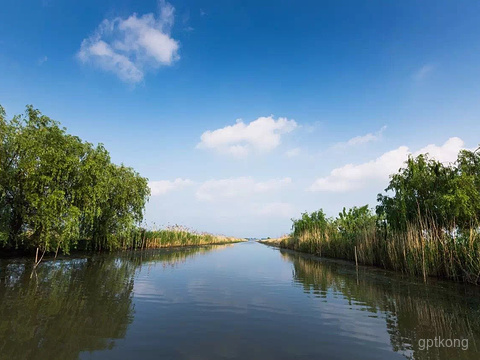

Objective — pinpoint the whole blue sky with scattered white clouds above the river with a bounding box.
[0,0,480,237]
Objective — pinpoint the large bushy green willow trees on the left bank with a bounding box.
[0,106,149,253]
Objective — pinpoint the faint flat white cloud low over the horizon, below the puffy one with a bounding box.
[196,177,292,201]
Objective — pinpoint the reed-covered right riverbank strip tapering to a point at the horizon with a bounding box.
[258,228,480,285]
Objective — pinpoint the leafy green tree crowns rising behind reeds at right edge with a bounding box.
[377,150,480,231]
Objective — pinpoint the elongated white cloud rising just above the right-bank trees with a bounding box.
[308,137,464,192]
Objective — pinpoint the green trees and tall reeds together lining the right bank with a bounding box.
[280,146,480,283]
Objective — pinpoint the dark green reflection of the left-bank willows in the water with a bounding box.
[0,247,227,360]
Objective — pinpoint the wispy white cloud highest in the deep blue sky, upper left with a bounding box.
[77,1,179,83]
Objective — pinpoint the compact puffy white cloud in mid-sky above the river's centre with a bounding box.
[197,115,297,158]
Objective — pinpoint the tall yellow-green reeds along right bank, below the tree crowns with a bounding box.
[279,217,480,284]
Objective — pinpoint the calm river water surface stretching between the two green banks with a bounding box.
[0,242,480,360]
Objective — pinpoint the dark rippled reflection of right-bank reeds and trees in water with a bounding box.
[282,252,480,359]
